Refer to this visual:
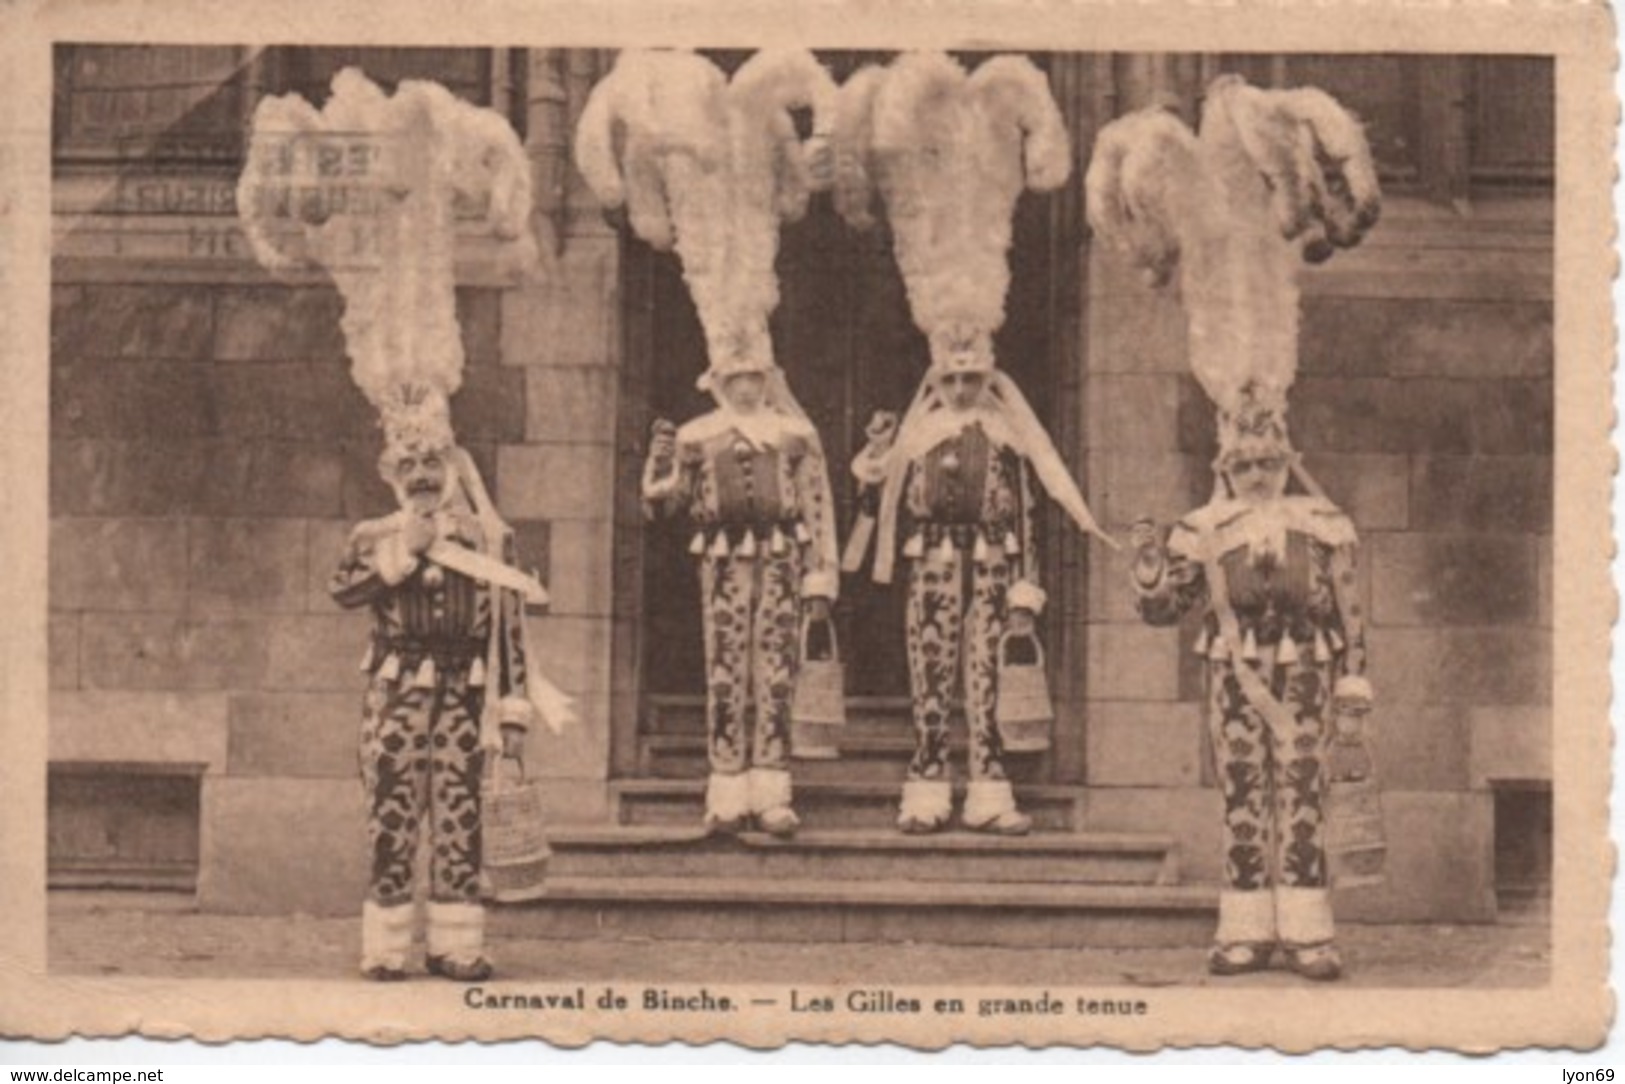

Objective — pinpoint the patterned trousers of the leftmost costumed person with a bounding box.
[361,668,484,907]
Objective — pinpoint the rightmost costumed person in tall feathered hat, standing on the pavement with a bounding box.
[1086,76,1380,980]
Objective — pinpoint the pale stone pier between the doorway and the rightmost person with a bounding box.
[1082,54,1217,879]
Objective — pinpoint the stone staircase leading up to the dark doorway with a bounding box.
[492,780,1217,947]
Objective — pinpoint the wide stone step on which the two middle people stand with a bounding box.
[549,826,1180,884]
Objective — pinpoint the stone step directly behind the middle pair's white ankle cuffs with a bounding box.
[609,778,1084,832]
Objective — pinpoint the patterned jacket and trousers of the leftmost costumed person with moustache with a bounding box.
[330,512,525,907]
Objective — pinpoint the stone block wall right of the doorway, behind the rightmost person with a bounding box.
[1084,203,1554,920]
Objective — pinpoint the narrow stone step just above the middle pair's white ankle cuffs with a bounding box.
[639,726,1048,787]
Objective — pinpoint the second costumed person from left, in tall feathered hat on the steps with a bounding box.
[575,50,840,835]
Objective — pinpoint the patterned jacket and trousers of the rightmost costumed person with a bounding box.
[1136,497,1368,903]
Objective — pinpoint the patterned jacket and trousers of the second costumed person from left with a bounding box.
[644,410,840,775]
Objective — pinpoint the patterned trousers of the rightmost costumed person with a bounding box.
[1209,661,1331,891]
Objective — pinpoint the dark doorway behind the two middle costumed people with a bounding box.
[616,52,1082,782]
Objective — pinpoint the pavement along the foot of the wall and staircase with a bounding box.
[47,892,1552,988]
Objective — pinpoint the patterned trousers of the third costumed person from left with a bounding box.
[907,551,1011,780]
